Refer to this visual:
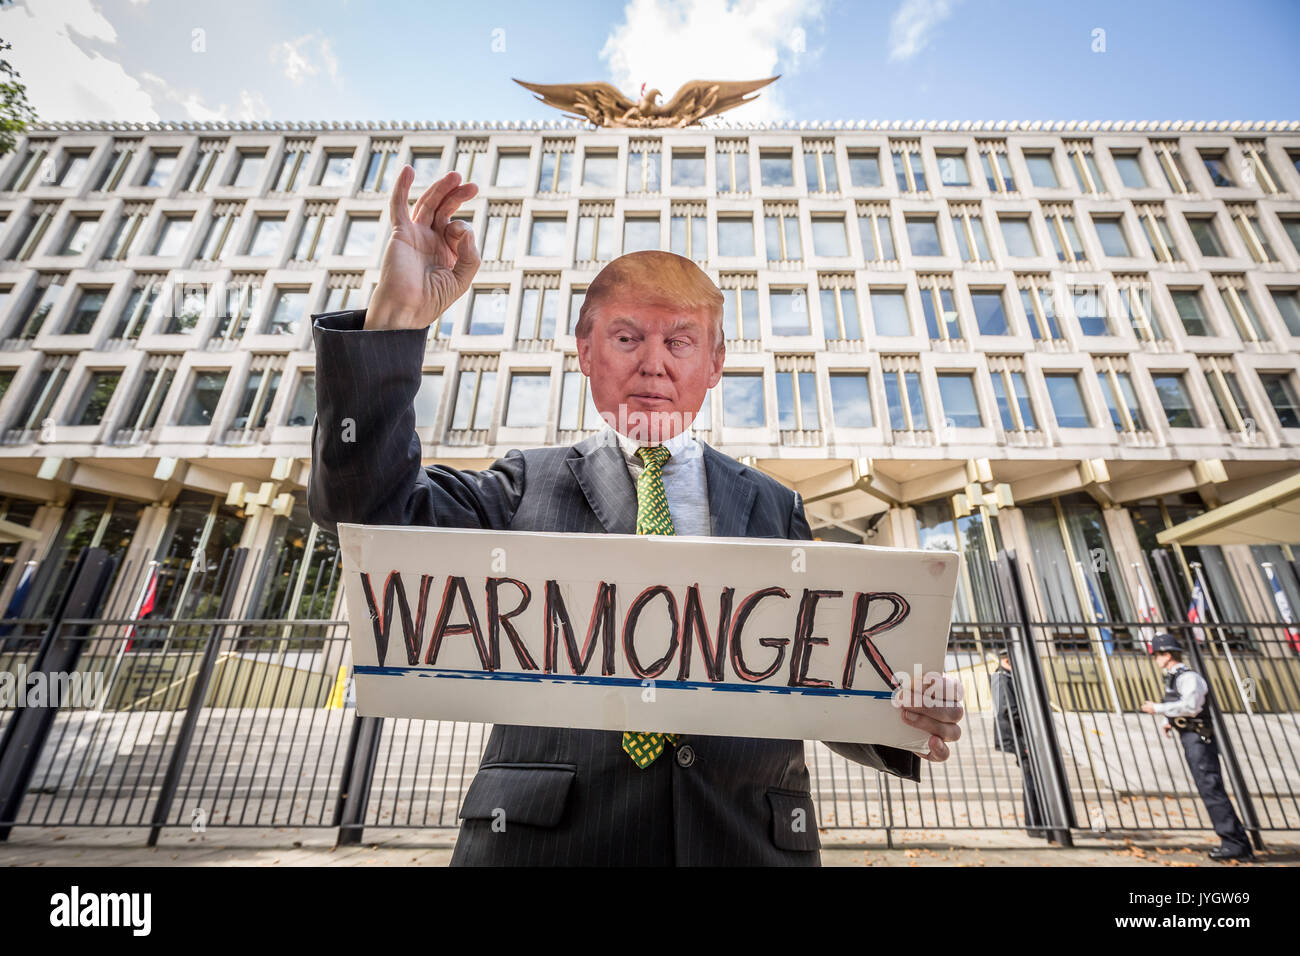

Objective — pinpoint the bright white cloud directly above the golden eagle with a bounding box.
[601,0,822,122]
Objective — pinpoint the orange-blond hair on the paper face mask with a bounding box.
[573,248,725,350]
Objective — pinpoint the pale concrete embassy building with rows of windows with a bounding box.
[0,115,1300,654]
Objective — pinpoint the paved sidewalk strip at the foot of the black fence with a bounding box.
[0,827,1300,866]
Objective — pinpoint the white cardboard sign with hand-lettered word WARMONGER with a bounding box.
[338,524,958,753]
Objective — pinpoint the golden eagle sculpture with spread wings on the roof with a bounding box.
[515,74,780,129]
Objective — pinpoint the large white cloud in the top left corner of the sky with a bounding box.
[0,0,159,122]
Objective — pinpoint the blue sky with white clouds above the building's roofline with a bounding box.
[0,0,1300,121]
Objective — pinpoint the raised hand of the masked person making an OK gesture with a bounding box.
[365,165,480,329]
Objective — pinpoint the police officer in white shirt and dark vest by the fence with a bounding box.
[1141,632,1255,860]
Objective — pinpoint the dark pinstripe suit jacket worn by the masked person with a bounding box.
[307,310,920,866]
